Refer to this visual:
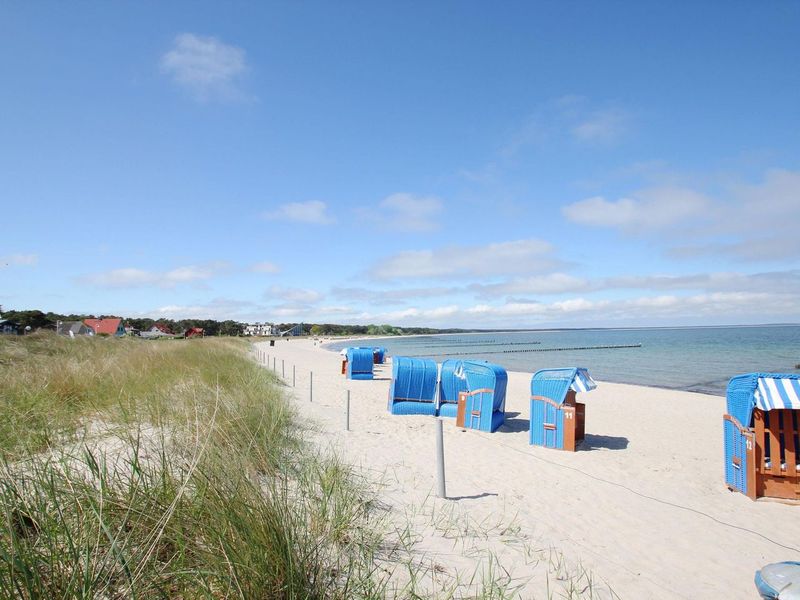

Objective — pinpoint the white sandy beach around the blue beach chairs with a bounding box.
[257,339,800,599]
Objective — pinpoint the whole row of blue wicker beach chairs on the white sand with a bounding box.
[342,348,800,500]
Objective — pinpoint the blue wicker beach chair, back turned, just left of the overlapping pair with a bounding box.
[389,356,438,416]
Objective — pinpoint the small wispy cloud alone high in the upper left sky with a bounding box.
[161,33,247,100]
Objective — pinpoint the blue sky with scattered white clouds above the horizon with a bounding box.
[0,0,800,328]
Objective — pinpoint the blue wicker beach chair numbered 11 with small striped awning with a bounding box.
[530,367,597,452]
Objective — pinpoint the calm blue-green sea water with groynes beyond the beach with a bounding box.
[326,325,800,395]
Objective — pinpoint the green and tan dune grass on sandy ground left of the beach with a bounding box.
[0,335,384,598]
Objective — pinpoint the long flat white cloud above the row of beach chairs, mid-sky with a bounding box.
[369,240,558,280]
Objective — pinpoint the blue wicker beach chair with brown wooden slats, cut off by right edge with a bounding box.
[723,373,800,500]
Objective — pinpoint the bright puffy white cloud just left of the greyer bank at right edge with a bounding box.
[562,187,711,232]
